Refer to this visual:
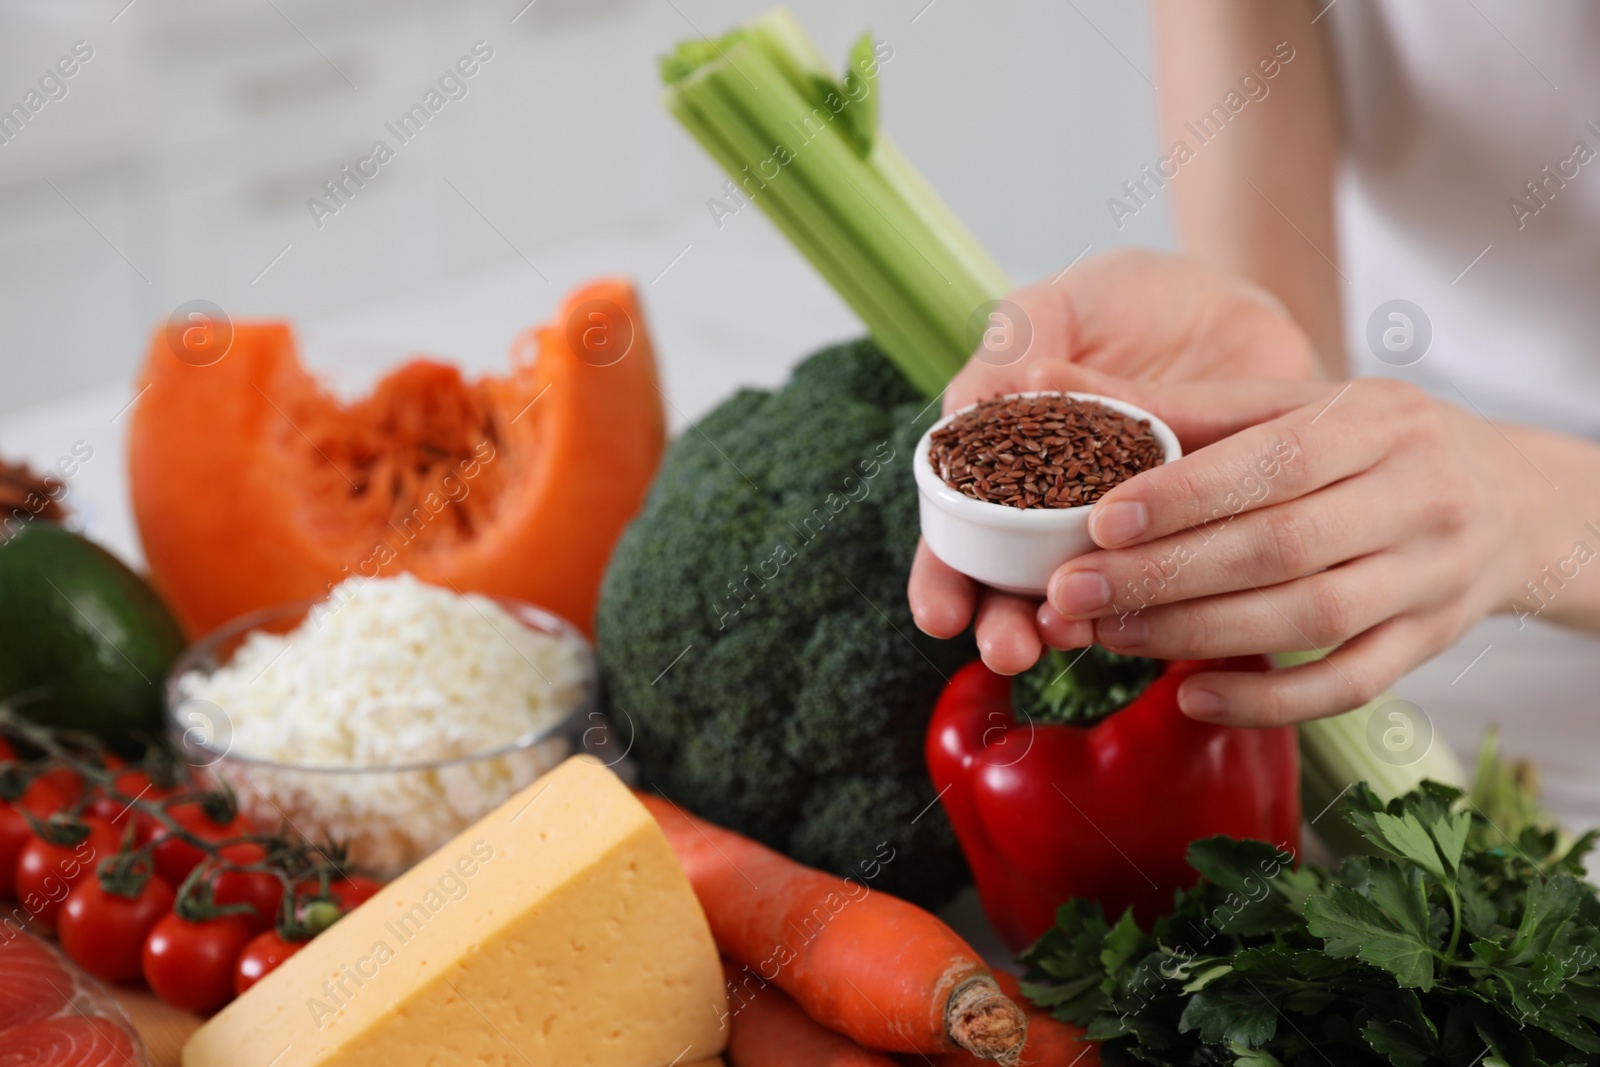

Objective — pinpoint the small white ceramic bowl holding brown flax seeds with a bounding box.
[912,392,1184,597]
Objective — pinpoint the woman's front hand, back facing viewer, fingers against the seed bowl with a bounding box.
[934,370,1600,726]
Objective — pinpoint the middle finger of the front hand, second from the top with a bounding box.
[1050,478,1429,619]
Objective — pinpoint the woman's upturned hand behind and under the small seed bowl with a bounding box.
[909,250,1318,673]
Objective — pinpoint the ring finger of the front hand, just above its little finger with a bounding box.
[1094,553,1434,659]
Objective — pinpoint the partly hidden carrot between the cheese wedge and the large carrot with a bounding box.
[722,960,902,1067]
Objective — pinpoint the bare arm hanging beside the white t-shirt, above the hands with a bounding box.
[1155,0,1346,376]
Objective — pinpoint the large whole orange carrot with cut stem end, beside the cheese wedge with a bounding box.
[640,795,1027,1064]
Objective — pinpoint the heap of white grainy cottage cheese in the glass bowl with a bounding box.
[178,574,594,873]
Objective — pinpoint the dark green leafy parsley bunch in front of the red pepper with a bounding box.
[1022,782,1600,1067]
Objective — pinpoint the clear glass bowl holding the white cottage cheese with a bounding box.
[163,597,598,880]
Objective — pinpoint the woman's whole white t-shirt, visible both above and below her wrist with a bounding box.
[1323,0,1600,831]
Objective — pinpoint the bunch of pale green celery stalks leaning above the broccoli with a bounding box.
[662,10,1011,395]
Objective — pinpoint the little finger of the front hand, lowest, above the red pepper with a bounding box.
[1178,616,1448,726]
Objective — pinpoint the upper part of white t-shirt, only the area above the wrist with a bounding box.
[1325,0,1600,438]
